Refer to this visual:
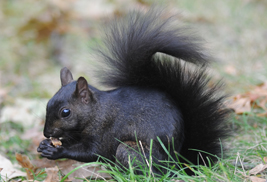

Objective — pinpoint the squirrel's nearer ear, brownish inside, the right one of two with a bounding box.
[74,77,92,104]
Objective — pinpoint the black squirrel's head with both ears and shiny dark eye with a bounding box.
[44,68,96,138]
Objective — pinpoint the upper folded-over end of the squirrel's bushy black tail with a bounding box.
[99,8,209,87]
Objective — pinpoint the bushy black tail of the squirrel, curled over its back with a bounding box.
[97,9,227,164]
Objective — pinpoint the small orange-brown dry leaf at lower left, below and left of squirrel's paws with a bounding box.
[16,153,36,180]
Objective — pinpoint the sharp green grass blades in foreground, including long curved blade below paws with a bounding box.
[31,123,267,182]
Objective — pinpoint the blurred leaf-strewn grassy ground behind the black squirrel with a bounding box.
[0,0,267,181]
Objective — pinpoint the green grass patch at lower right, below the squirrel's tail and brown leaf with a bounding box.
[65,115,267,182]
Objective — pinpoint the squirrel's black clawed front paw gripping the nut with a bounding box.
[37,139,65,160]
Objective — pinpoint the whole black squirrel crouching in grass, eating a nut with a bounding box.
[37,9,229,175]
